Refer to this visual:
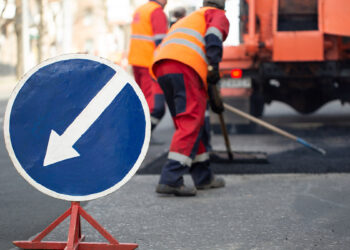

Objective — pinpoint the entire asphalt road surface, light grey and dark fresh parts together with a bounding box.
[0,96,350,250]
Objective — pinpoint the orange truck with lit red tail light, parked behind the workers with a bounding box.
[220,0,350,125]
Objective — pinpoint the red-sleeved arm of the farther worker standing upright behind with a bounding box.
[151,8,168,46]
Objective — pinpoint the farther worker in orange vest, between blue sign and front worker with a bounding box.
[128,0,168,130]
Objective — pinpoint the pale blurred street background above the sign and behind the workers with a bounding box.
[0,0,239,79]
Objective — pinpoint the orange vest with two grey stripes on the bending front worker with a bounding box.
[151,7,215,86]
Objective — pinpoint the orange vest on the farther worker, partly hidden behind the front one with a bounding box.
[128,1,161,68]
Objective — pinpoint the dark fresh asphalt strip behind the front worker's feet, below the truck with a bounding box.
[138,126,350,175]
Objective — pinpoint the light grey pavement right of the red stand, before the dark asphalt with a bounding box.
[11,174,350,250]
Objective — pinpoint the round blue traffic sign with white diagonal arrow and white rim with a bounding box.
[4,54,150,201]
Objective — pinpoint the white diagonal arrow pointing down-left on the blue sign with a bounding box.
[44,74,127,167]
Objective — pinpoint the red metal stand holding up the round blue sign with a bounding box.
[13,202,138,250]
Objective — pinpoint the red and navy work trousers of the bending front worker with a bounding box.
[155,60,212,186]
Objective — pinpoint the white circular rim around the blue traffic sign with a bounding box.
[4,54,151,201]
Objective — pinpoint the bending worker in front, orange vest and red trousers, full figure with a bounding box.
[151,0,229,196]
